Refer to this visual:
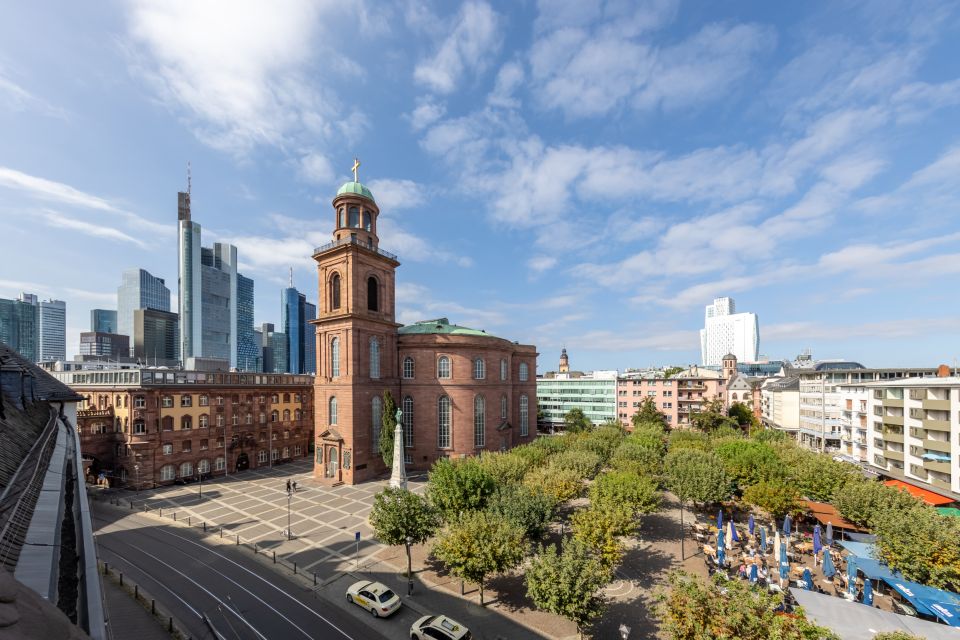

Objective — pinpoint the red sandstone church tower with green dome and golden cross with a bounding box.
[313,160,400,484]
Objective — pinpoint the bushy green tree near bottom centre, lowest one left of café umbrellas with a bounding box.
[526,538,611,632]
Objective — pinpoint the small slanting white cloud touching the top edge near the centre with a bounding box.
[413,2,502,94]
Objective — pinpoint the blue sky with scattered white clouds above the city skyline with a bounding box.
[0,0,960,371]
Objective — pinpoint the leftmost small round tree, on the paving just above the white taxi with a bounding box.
[370,487,440,577]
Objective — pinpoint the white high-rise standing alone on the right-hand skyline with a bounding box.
[700,298,760,366]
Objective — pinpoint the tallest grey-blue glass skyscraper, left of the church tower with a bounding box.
[177,182,253,371]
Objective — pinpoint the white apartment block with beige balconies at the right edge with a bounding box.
[865,376,960,499]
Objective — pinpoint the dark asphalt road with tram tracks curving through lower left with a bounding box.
[93,502,390,640]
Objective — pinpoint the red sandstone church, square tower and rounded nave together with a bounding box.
[313,182,537,484]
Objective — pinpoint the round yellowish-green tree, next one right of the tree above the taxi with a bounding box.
[433,511,524,606]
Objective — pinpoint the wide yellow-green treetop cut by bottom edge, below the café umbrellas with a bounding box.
[657,571,839,640]
